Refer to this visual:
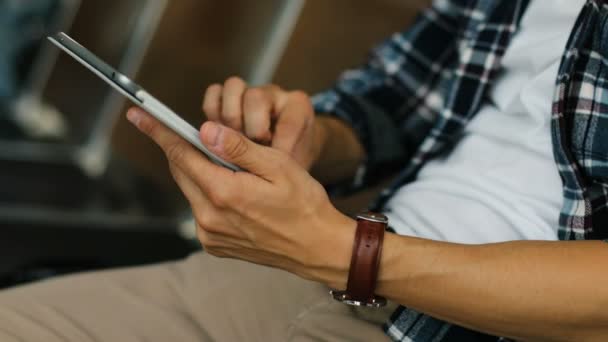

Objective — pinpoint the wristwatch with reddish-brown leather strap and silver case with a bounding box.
[330,212,388,308]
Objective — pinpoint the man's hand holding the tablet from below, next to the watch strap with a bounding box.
[127,108,356,288]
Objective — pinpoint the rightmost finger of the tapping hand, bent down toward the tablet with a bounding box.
[272,92,312,154]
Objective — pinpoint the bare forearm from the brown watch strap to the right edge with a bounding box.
[377,234,608,341]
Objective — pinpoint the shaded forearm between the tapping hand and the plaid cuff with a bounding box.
[311,116,365,184]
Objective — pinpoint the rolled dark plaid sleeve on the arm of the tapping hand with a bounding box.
[313,0,465,188]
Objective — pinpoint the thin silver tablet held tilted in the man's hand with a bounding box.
[48,32,242,171]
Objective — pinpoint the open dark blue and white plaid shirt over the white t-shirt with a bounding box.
[313,0,608,341]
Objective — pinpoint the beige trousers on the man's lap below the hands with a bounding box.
[0,253,394,342]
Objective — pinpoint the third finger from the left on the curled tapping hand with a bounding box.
[243,88,273,144]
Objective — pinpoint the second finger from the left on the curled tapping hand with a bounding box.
[221,77,247,131]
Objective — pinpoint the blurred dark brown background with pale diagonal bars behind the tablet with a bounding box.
[0,0,430,288]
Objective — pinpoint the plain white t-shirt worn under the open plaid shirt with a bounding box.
[386,0,585,243]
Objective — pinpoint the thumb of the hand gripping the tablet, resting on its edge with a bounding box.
[200,121,278,180]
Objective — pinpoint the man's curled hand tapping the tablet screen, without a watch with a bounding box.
[203,77,326,170]
